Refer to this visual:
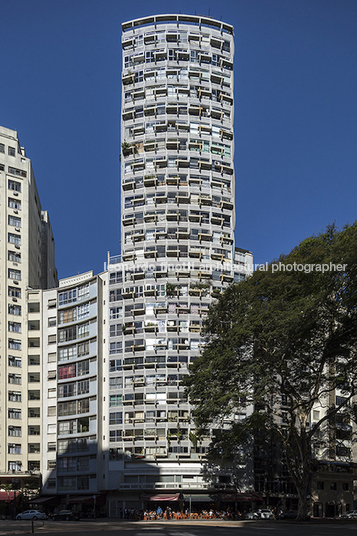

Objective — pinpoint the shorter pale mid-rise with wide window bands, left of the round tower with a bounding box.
[42,272,108,505]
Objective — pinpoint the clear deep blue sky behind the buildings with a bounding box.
[0,0,357,277]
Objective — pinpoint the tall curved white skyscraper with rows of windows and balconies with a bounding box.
[104,14,252,515]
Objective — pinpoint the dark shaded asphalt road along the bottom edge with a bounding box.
[0,519,357,536]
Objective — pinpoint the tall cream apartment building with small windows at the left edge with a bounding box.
[0,127,57,487]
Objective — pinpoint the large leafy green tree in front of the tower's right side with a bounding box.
[186,223,357,519]
